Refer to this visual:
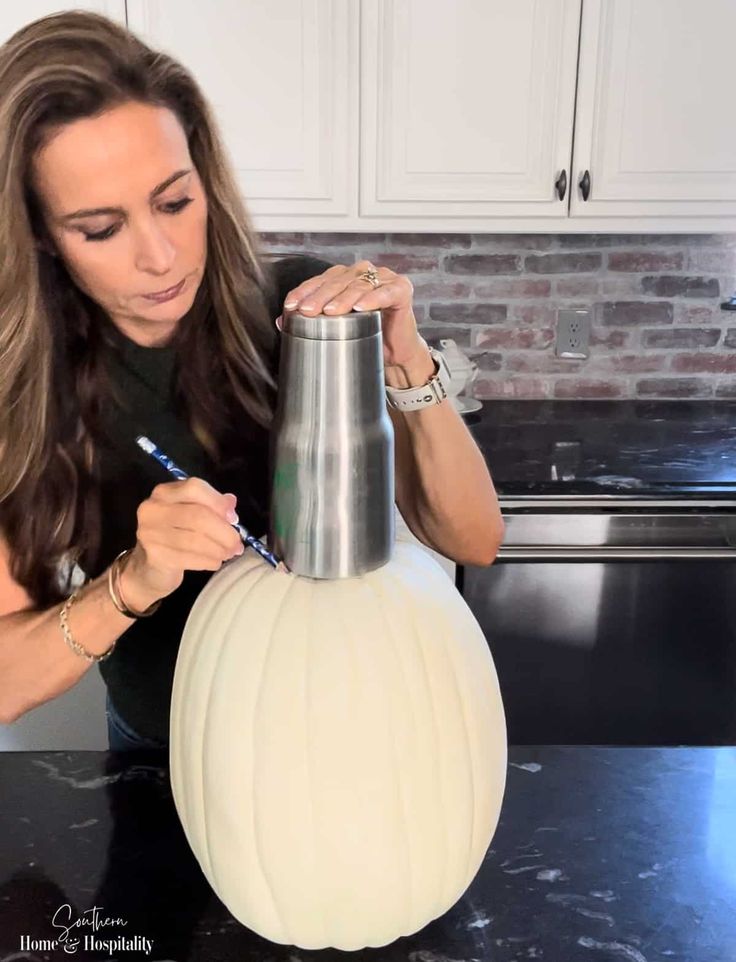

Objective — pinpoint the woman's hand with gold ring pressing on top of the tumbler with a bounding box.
[284,261,428,367]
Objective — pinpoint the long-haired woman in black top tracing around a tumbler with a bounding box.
[0,11,502,748]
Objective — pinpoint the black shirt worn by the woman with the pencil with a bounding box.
[91,255,332,743]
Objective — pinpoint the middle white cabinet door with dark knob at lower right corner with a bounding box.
[361,0,580,218]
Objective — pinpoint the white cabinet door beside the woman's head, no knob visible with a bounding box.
[127,0,359,219]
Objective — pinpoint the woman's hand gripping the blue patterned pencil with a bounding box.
[120,478,244,610]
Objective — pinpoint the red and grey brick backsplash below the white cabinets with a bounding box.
[261,233,736,399]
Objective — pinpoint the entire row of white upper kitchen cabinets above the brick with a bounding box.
[7,0,736,233]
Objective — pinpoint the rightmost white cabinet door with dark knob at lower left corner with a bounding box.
[570,0,736,218]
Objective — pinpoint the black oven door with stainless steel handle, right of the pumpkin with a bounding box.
[458,499,736,745]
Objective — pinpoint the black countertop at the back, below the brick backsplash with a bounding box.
[464,400,736,497]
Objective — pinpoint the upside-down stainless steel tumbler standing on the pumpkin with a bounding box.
[269,311,395,578]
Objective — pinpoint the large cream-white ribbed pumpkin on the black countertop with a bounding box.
[170,541,506,951]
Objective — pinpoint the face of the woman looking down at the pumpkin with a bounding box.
[33,103,207,347]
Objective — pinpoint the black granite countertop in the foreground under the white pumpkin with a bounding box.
[0,747,736,962]
